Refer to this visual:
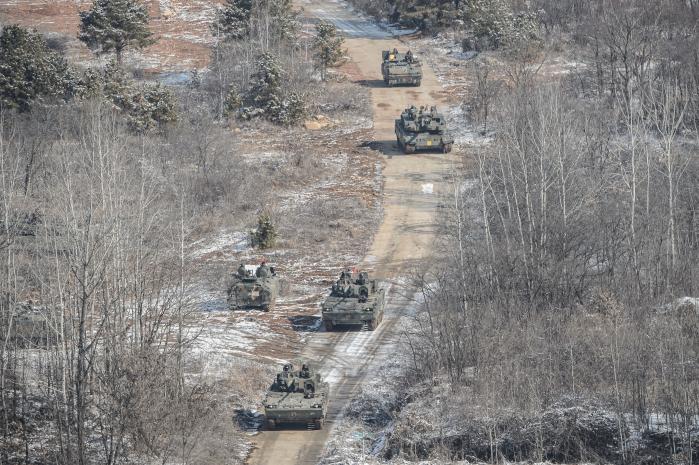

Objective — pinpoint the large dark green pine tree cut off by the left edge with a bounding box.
[0,25,76,111]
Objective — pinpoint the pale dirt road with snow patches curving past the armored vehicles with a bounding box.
[248,0,454,465]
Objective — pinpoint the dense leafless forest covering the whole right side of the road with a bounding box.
[353,0,699,463]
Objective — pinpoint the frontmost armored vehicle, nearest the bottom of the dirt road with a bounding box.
[263,363,330,429]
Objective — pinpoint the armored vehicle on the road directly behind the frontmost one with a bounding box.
[322,270,386,331]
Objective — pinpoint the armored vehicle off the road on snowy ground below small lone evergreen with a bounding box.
[228,262,279,312]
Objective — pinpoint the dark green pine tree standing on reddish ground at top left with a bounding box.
[78,0,155,66]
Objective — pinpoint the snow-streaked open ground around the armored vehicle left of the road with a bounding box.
[176,135,382,392]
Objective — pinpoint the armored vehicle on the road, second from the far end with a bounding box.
[395,105,454,153]
